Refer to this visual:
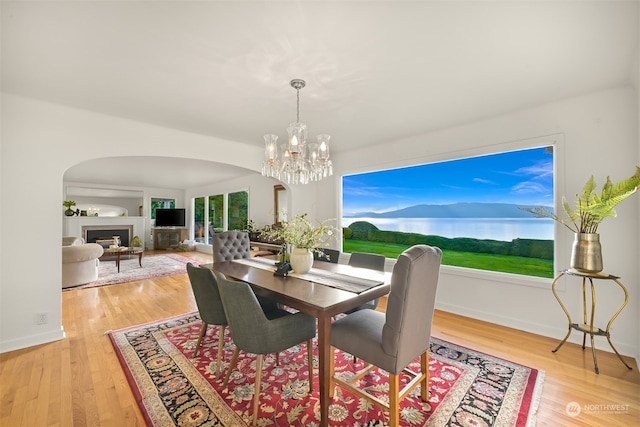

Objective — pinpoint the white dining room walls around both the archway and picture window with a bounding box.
[0,87,640,355]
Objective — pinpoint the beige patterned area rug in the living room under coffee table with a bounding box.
[62,254,199,291]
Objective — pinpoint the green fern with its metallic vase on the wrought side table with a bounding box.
[523,166,640,273]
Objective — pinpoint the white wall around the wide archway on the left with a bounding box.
[0,94,263,352]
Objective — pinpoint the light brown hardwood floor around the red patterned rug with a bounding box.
[0,252,640,427]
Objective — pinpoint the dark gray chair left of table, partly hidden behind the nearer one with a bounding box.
[187,263,227,376]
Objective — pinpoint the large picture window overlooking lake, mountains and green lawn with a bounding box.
[342,146,554,277]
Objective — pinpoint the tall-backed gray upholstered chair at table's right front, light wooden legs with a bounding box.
[330,245,442,427]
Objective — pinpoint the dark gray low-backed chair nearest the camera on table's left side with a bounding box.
[216,273,316,426]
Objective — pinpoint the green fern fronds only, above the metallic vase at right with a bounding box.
[521,166,640,233]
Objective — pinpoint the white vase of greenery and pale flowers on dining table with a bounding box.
[262,213,336,274]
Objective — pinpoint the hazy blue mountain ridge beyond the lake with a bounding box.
[345,202,552,218]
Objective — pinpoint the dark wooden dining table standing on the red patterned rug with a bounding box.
[212,258,391,427]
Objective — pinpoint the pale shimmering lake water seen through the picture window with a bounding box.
[342,218,554,242]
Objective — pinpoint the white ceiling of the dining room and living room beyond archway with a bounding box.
[1,0,638,188]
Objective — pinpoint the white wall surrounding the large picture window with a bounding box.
[316,87,640,356]
